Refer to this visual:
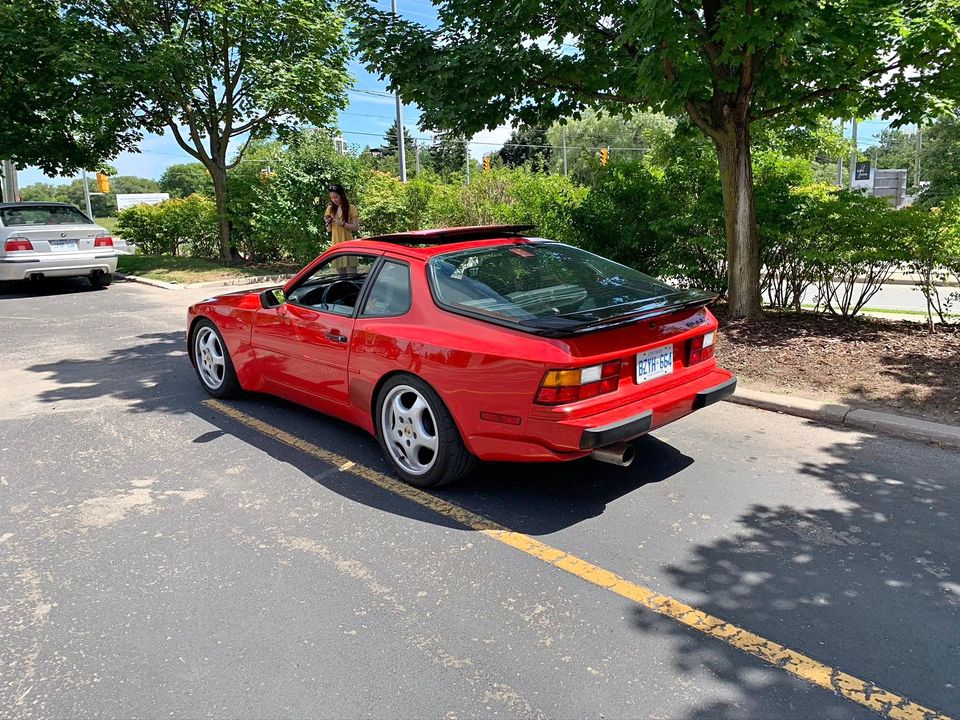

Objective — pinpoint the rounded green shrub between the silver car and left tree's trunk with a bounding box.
[117,195,220,258]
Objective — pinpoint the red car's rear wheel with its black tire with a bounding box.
[374,374,476,488]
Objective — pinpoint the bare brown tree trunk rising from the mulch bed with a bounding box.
[714,122,760,318]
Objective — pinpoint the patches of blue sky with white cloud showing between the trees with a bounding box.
[19,0,889,187]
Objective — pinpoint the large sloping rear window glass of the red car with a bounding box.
[430,242,713,330]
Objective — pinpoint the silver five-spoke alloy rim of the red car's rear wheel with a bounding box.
[380,385,440,476]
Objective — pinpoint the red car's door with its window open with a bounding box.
[251,253,377,411]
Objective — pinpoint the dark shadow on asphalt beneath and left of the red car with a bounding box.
[29,332,692,534]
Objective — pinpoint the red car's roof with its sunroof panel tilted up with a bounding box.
[338,225,543,259]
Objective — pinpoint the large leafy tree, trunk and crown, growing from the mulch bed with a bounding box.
[351,0,960,317]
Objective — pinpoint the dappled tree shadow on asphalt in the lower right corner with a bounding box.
[634,434,960,719]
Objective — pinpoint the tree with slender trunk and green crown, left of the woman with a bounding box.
[72,0,348,260]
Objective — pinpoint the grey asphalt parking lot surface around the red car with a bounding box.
[0,281,960,719]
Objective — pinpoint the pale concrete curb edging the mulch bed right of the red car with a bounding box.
[726,387,960,449]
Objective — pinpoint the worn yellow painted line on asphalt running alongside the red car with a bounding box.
[203,400,950,720]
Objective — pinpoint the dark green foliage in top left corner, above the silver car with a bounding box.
[0,0,140,176]
